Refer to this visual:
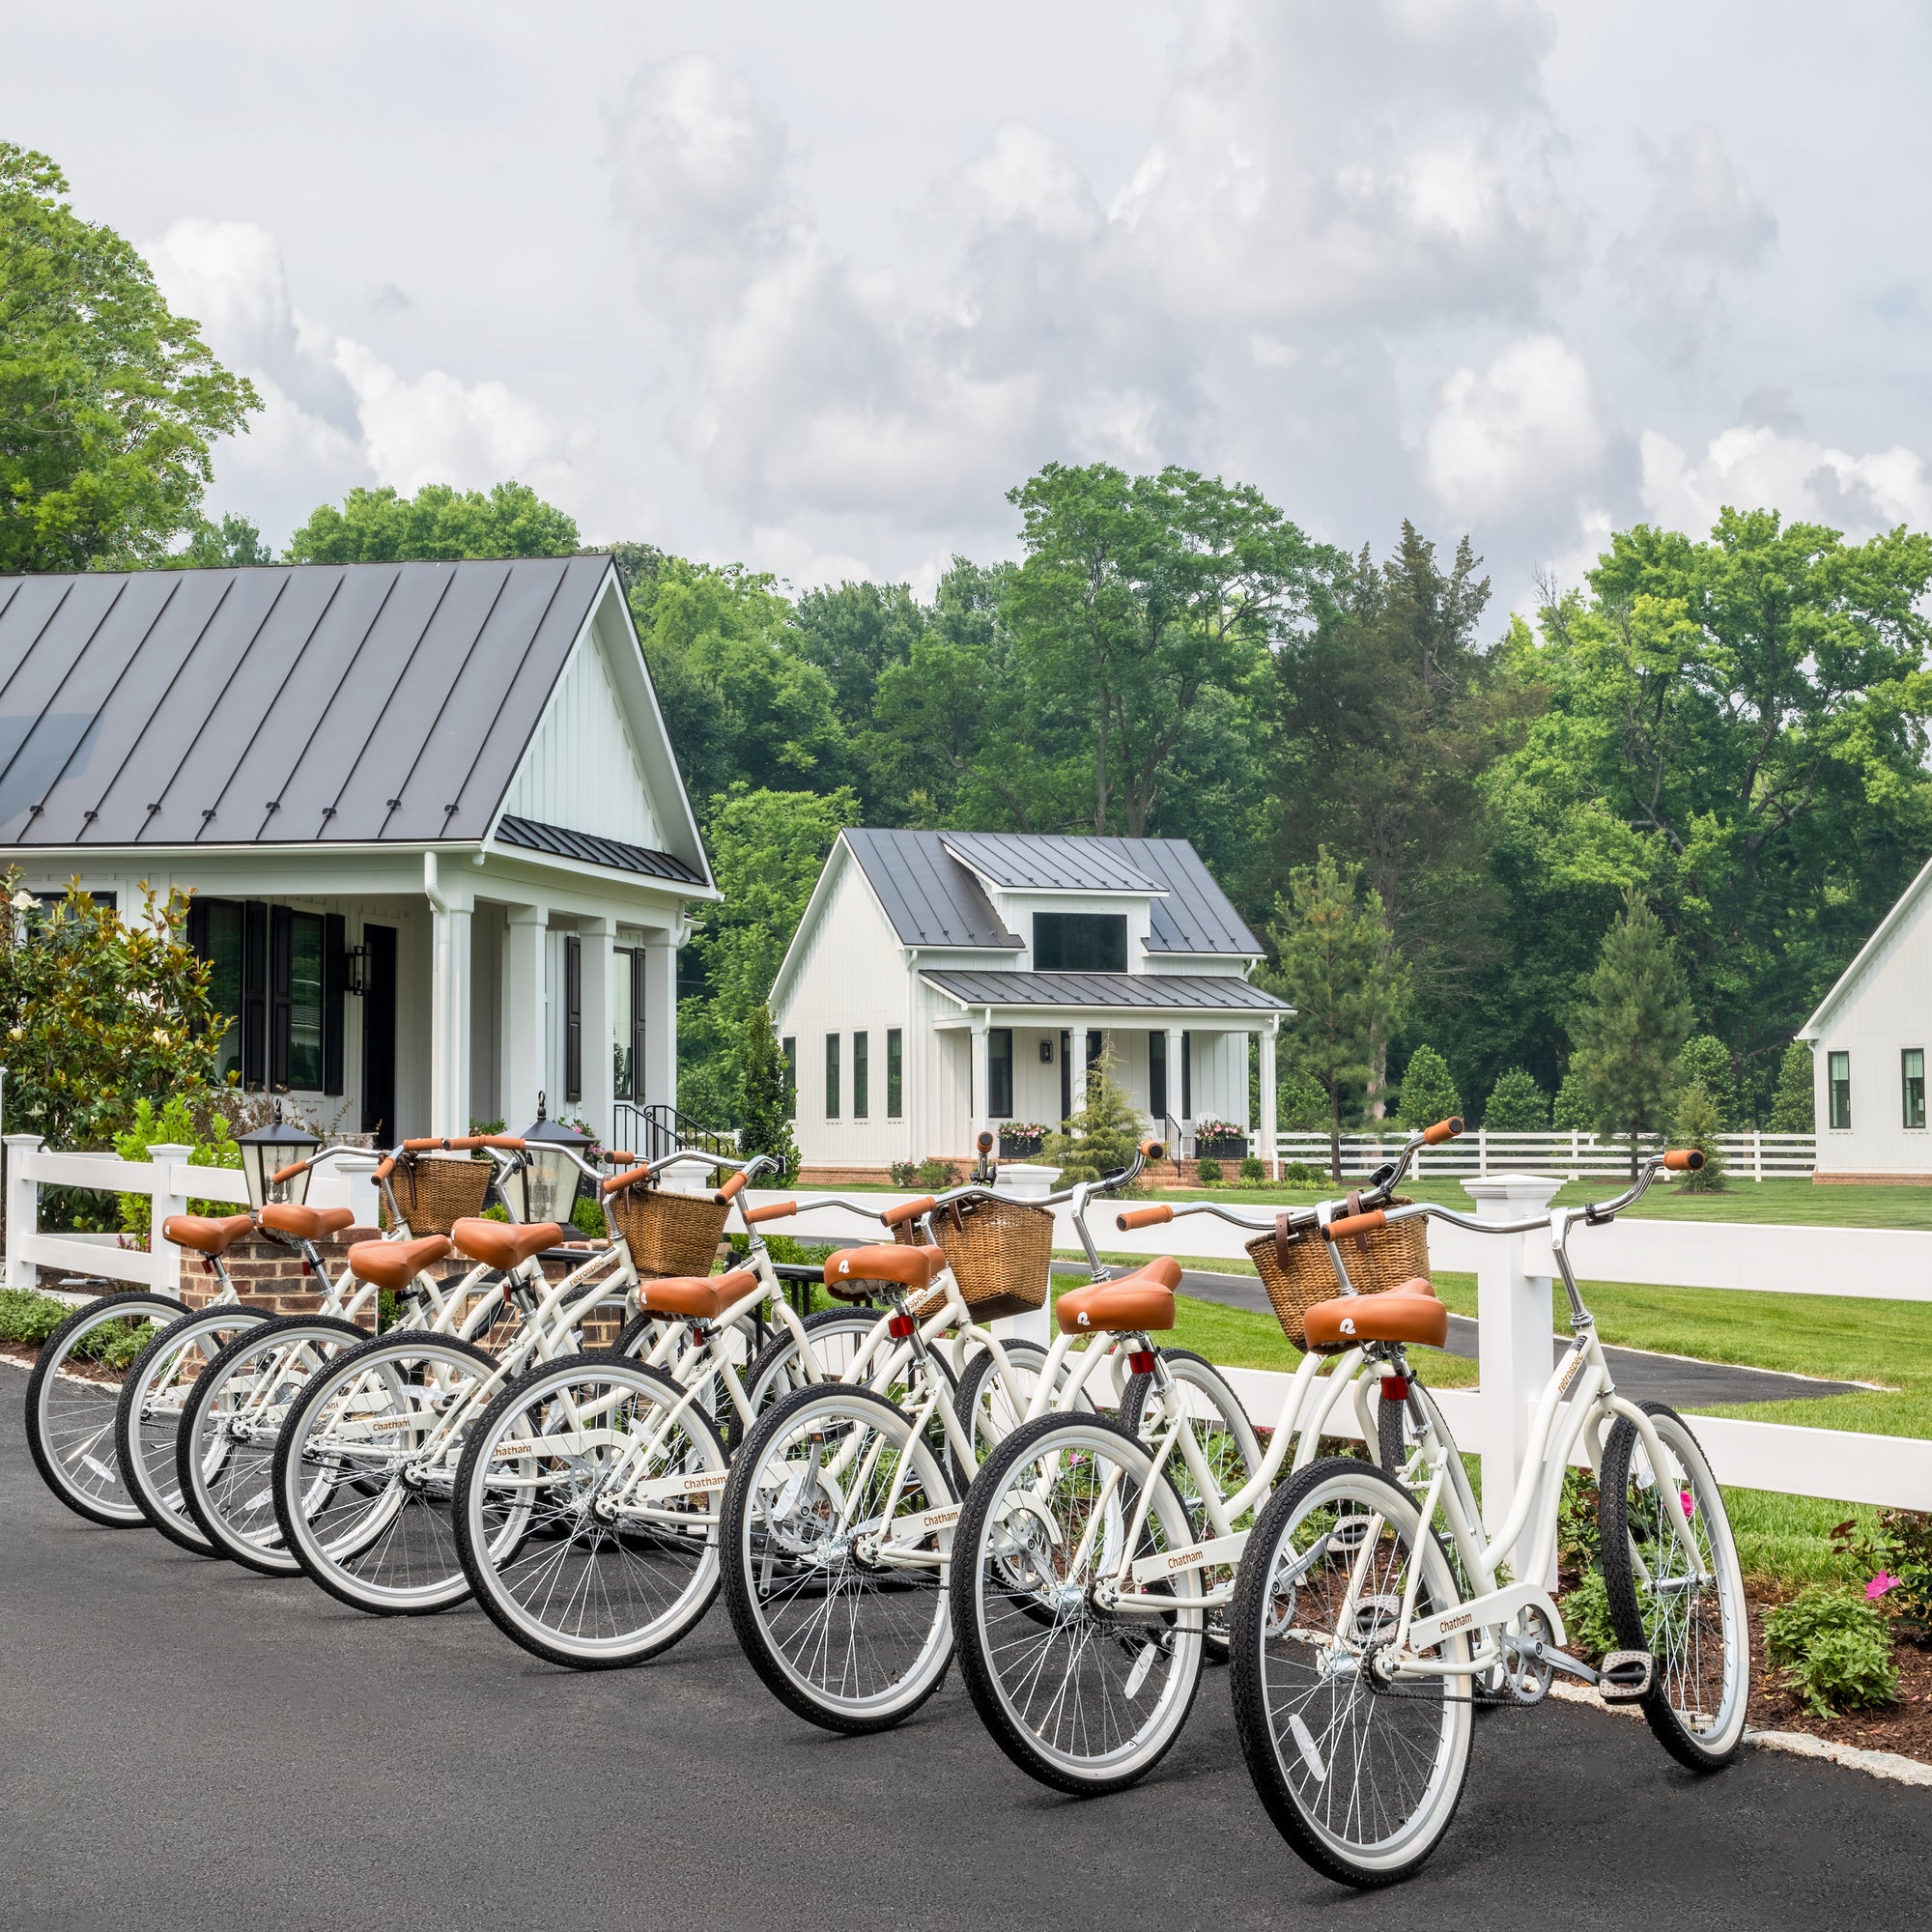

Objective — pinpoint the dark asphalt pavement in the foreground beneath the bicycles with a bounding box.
[0,1414,1932,1932]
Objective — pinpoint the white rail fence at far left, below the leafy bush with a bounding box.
[6,1134,377,1294]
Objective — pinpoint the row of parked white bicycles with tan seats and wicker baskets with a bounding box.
[27,1121,1748,1886]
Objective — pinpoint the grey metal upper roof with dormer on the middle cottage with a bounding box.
[844,831,1262,958]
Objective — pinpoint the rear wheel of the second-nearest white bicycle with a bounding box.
[951,1416,1204,1795]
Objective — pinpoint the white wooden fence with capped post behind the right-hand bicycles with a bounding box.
[752,1175,1932,1509]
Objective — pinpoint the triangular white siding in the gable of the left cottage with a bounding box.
[502,624,667,852]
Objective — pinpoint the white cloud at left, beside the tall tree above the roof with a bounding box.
[143,218,589,541]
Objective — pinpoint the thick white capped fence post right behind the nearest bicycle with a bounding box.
[1463,1175,1563,1588]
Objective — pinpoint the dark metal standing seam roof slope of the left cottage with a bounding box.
[0,556,626,846]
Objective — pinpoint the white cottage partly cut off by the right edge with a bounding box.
[1799,862,1932,1182]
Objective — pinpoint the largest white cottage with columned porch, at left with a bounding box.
[0,556,719,1144]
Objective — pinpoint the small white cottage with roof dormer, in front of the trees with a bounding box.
[771,831,1289,1180]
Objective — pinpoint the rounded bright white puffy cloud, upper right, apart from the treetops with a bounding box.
[1422,334,1607,520]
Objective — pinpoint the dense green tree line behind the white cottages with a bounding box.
[14,145,1932,1134]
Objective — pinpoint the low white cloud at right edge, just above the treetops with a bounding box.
[1642,425,1932,539]
